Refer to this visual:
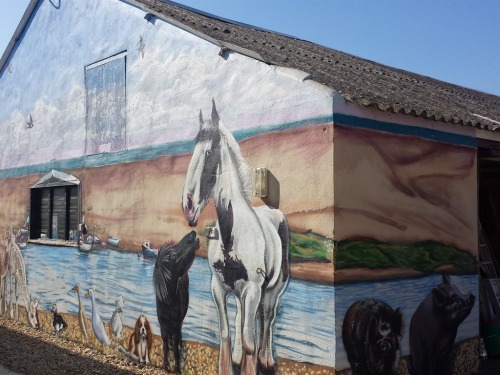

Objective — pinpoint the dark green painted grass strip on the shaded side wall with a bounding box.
[335,240,477,274]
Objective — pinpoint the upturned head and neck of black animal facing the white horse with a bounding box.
[153,231,200,301]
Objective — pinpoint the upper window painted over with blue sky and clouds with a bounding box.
[85,52,126,155]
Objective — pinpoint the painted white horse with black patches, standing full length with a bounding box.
[182,101,289,375]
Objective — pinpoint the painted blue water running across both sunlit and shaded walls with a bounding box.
[23,244,479,369]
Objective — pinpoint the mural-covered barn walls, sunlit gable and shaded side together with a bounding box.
[0,0,495,374]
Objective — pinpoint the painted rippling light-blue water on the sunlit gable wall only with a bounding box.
[23,244,335,367]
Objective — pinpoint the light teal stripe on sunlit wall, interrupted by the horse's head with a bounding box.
[0,116,333,179]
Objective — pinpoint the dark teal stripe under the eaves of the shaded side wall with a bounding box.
[333,113,477,147]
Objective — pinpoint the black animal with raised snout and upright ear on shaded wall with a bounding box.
[409,275,475,375]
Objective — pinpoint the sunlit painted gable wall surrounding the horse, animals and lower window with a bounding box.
[0,0,335,373]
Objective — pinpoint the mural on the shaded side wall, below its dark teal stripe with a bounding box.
[335,125,479,375]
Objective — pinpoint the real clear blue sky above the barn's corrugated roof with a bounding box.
[0,0,500,95]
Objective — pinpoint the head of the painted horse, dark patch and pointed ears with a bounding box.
[182,99,221,227]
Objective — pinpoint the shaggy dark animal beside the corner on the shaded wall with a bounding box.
[342,299,403,375]
